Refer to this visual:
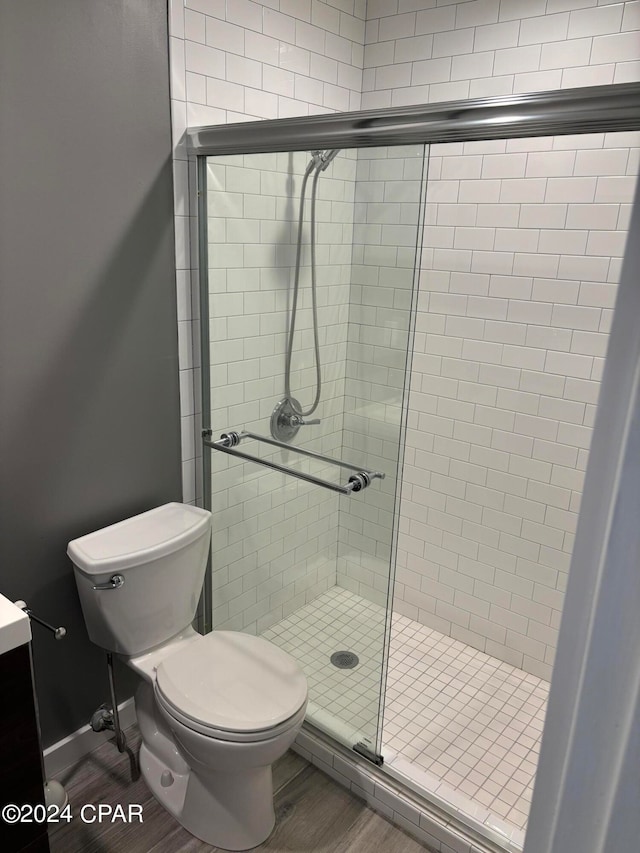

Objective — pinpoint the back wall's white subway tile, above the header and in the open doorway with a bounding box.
[354,0,640,678]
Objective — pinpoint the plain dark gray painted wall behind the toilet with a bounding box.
[0,0,181,746]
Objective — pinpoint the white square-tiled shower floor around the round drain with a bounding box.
[264,587,548,843]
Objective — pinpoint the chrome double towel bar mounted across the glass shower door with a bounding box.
[203,430,384,495]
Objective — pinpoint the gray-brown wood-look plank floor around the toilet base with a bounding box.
[49,727,426,853]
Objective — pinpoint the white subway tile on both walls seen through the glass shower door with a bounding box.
[208,146,424,628]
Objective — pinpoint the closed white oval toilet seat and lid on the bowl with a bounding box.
[155,631,307,742]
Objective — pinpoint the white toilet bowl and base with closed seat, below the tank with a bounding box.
[125,631,307,850]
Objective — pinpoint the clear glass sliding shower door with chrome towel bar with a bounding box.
[200,141,425,759]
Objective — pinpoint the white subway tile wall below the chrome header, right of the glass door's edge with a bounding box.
[392,134,640,678]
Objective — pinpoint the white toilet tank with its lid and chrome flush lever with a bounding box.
[67,503,211,655]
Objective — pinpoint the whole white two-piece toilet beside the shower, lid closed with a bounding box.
[67,503,307,850]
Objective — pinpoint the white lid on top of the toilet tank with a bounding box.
[67,503,211,575]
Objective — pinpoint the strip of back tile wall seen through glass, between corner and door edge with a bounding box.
[337,145,425,608]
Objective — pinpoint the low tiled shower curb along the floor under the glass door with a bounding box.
[292,722,522,853]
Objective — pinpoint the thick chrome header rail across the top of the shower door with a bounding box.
[187,83,640,157]
